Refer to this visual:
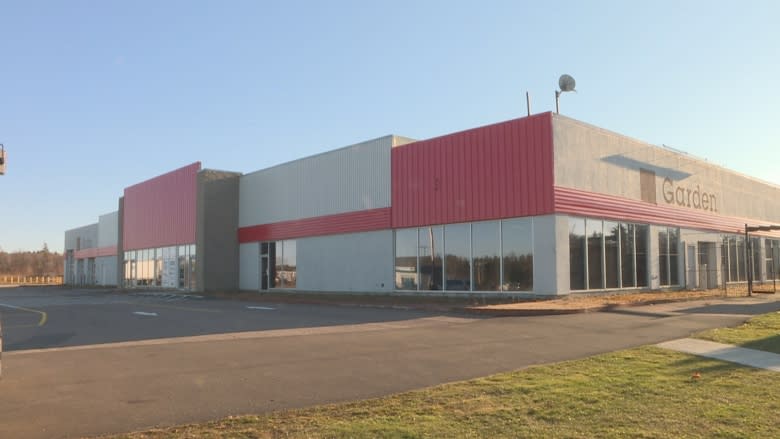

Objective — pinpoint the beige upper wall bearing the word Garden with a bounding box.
[553,115,780,223]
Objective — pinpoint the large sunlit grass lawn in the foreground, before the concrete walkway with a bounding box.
[111,347,780,439]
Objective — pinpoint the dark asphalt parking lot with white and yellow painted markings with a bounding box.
[0,287,438,351]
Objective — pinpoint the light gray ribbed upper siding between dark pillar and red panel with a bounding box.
[239,136,397,227]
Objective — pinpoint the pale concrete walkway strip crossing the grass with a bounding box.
[657,338,780,372]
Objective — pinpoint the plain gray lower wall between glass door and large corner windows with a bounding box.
[296,230,394,293]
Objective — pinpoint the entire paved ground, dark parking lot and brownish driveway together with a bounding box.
[0,288,780,439]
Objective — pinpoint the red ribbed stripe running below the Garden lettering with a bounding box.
[555,186,780,236]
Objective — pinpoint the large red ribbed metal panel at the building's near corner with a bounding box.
[392,113,553,228]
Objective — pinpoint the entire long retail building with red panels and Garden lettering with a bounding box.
[65,113,780,295]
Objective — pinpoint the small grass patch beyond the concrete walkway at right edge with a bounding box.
[694,312,780,354]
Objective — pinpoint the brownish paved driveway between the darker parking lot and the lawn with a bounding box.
[0,288,780,438]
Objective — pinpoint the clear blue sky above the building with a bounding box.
[0,0,780,251]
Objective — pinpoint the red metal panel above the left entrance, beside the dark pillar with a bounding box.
[122,162,200,250]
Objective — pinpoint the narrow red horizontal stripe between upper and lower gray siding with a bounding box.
[238,207,390,243]
